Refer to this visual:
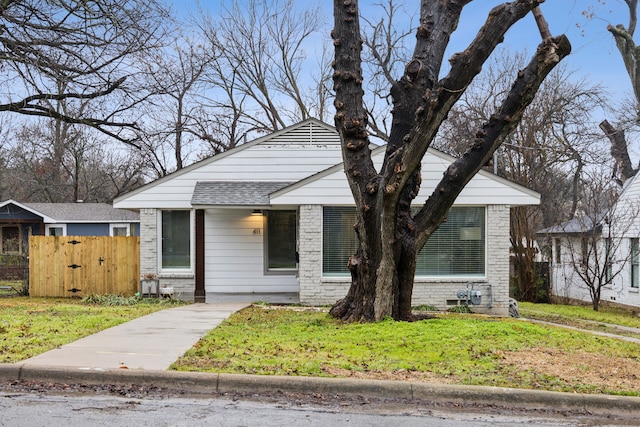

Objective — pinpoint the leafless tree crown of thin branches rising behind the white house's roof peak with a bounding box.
[201,0,322,139]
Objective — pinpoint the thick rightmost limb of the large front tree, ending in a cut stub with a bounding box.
[415,36,571,248]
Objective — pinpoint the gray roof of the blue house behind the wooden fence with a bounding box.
[22,203,140,223]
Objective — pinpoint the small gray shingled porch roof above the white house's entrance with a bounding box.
[191,181,293,206]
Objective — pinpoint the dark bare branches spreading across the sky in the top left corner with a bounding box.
[0,0,167,145]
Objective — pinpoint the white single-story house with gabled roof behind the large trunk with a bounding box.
[114,119,539,315]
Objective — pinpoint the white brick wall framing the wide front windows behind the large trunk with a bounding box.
[299,205,509,316]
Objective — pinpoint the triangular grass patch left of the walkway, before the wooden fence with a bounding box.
[0,297,174,363]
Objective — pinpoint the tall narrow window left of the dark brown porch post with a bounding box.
[161,211,191,269]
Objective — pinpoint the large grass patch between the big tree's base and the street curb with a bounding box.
[173,306,640,395]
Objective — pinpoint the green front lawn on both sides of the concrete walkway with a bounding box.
[0,296,640,396]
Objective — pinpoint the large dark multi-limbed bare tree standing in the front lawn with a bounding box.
[331,0,571,321]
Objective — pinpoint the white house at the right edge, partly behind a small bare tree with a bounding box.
[537,174,640,307]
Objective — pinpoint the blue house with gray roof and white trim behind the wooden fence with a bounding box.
[0,200,140,253]
